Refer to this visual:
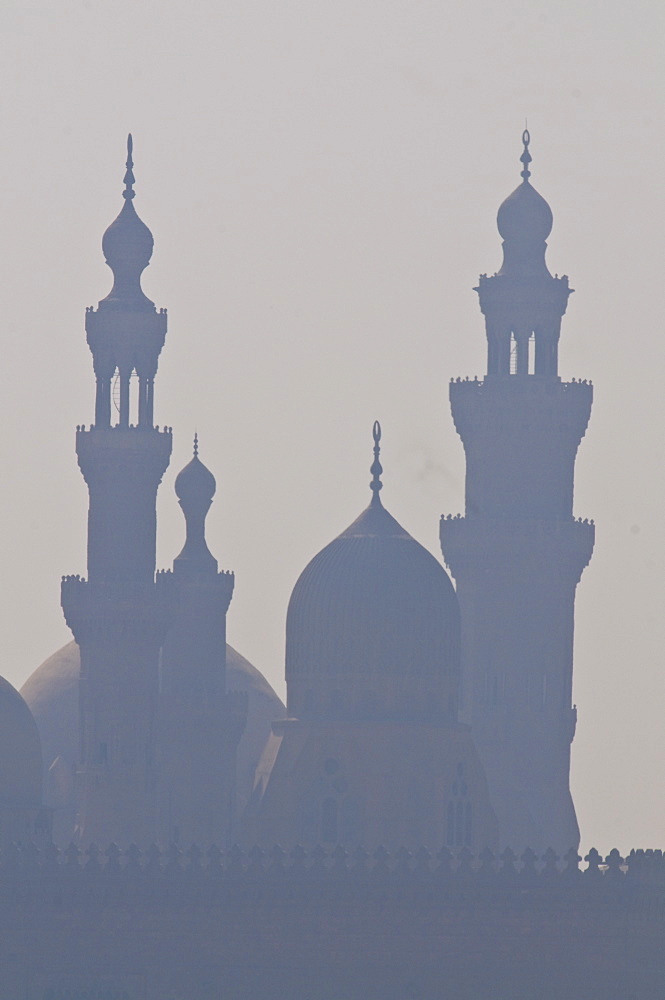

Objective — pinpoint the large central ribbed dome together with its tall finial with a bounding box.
[286,425,460,716]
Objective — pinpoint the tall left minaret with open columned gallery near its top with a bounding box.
[62,136,171,844]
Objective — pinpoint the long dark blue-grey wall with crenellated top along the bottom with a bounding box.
[0,849,665,1000]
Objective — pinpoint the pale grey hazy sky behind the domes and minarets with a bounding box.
[0,0,665,851]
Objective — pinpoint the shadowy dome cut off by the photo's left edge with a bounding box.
[0,677,42,807]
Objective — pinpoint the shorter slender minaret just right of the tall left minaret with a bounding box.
[158,436,247,846]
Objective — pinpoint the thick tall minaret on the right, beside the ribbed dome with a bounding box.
[441,131,594,852]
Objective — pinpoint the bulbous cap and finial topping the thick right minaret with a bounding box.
[496,129,554,276]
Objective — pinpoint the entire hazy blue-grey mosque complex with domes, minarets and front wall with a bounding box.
[0,131,665,1000]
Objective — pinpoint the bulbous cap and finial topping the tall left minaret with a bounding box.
[100,135,154,310]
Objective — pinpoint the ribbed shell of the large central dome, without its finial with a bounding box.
[286,495,460,681]
